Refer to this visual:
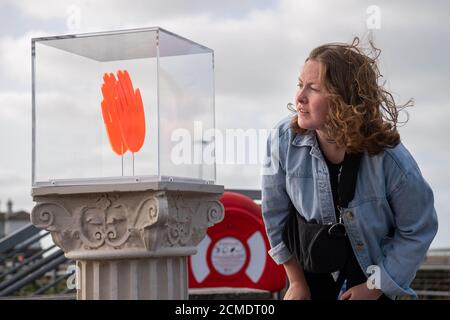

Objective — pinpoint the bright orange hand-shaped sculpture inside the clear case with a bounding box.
[101,70,145,155]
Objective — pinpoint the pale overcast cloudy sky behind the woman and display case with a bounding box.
[0,0,450,247]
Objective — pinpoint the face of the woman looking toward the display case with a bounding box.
[295,60,329,130]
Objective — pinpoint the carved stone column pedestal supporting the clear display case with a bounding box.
[31,182,224,300]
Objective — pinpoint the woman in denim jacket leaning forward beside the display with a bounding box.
[262,38,437,300]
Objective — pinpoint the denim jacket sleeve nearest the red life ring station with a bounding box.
[262,129,291,264]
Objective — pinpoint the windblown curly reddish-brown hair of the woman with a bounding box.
[288,37,414,155]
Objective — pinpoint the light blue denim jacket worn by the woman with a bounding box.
[262,117,438,299]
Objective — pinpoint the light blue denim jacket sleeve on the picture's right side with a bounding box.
[378,166,438,298]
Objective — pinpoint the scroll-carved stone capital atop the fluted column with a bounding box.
[31,190,224,260]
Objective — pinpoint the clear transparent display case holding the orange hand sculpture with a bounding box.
[32,28,215,187]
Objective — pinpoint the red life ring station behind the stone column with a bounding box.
[189,192,286,292]
